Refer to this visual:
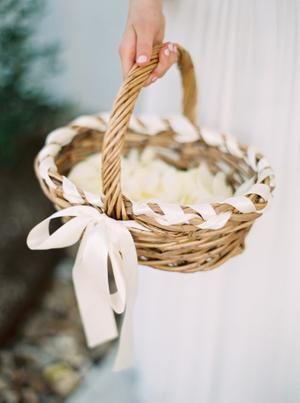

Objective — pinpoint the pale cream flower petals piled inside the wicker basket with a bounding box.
[69,147,232,205]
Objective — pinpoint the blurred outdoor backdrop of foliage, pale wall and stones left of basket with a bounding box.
[0,0,126,403]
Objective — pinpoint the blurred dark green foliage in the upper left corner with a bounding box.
[0,0,68,164]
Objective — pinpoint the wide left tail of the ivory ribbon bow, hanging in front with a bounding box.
[72,226,118,348]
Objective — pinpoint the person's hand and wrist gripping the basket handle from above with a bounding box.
[119,0,177,85]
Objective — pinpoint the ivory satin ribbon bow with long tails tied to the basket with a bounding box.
[27,206,138,370]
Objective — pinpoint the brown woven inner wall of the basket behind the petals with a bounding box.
[55,128,255,198]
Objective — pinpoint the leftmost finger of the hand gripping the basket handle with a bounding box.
[119,26,136,79]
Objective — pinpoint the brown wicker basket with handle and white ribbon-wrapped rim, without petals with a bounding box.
[35,45,274,273]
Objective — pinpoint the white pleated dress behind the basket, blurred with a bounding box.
[136,0,300,403]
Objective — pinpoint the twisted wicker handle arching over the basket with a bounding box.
[102,44,197,220]
